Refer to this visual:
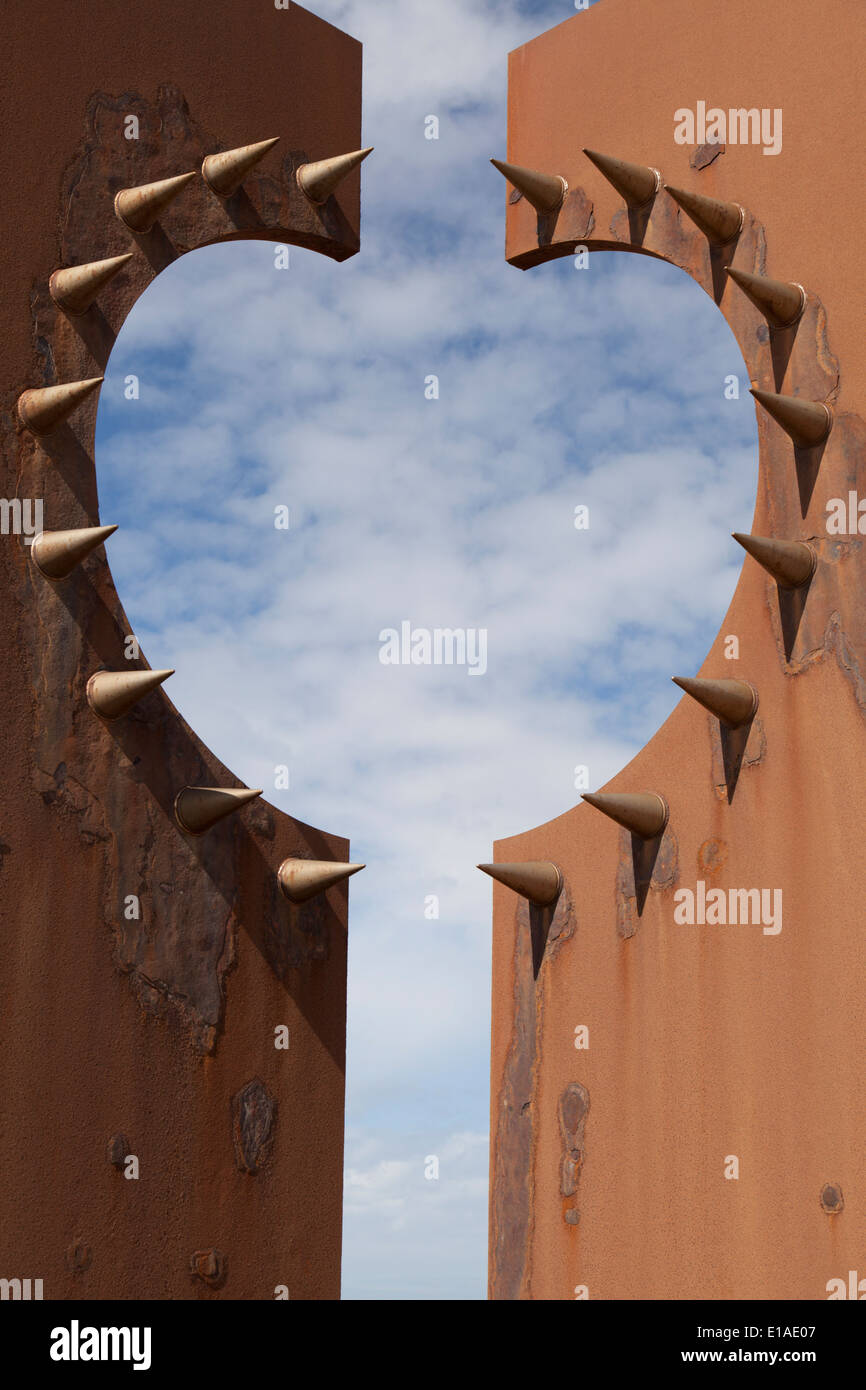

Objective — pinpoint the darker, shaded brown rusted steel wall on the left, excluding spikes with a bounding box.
[0,0,361,1300]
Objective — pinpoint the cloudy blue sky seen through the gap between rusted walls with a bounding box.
[96,0,758,1298]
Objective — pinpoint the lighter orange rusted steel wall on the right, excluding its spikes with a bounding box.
[491,0,866,1300]
